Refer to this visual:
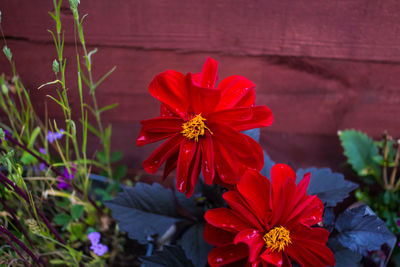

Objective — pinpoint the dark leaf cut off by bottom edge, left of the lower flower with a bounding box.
[141,246,195,267]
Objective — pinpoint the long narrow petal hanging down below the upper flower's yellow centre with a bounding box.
[176,138,197,193]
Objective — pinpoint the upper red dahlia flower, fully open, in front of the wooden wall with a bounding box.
[136,58,272,196]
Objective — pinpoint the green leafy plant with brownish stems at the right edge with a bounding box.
[339,130,400,264]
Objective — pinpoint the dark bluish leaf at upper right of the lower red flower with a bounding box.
[296,167,358,207]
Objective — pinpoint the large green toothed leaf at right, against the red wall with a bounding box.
[339,130,381,177]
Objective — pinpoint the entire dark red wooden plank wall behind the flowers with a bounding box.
[0,0,400,180]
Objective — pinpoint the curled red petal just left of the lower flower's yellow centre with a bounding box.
[234,229,265,262]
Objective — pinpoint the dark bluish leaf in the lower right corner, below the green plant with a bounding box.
[335,205,396,255]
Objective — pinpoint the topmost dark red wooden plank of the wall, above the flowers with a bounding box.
[0,0,400,62]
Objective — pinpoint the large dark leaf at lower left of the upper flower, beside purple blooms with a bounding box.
[104,183,179,243]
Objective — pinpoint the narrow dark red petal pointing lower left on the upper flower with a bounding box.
[143,134,183,173]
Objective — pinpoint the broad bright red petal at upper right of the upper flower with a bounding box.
[216,75,255,110]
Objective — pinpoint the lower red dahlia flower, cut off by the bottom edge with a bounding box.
[204,164,335,267]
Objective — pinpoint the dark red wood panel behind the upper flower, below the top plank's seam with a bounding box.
[0,41,400,176]
